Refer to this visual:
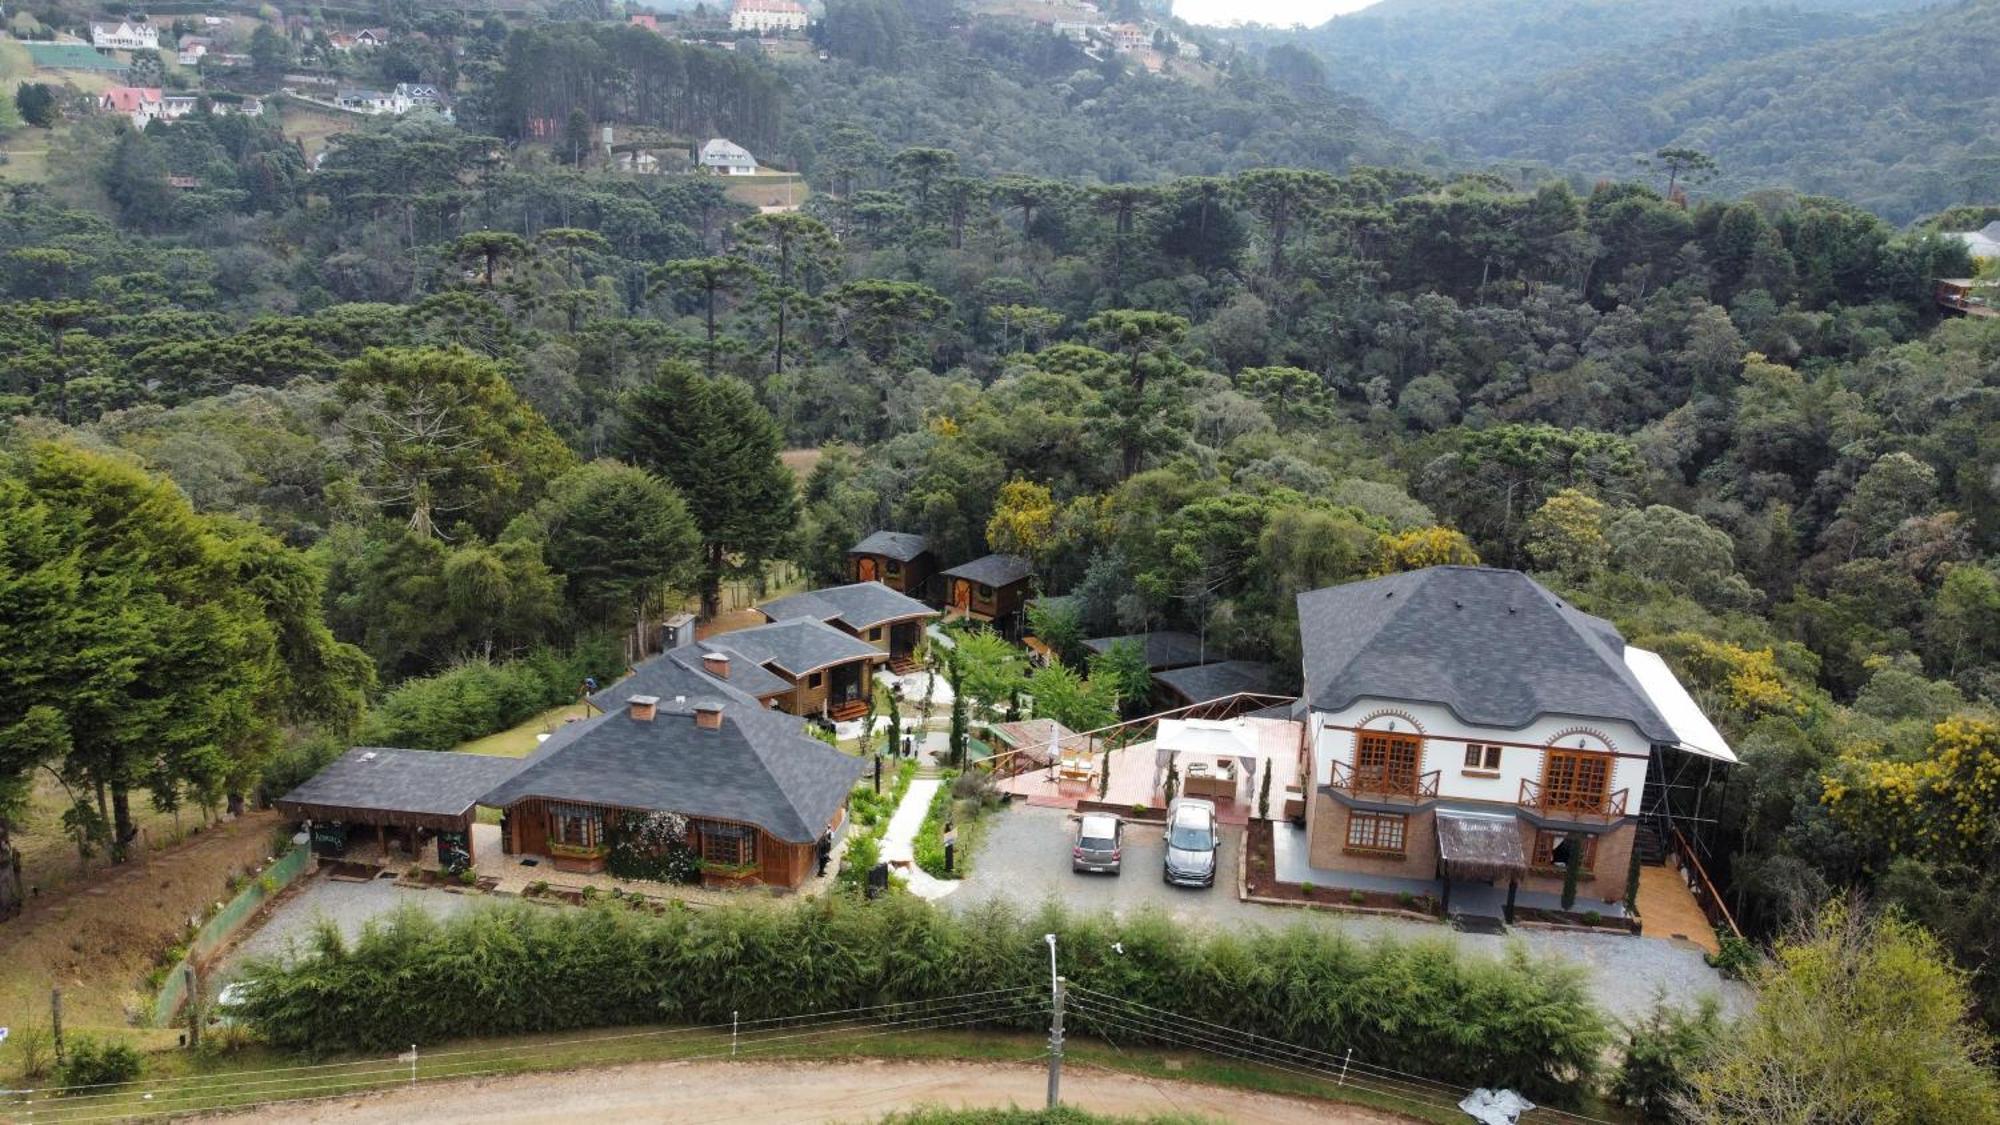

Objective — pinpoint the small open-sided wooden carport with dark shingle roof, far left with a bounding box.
[276,747,520,865]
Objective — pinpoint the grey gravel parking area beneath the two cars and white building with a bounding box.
[942,805,1750,1017]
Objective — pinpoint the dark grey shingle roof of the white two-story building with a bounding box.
[1298,567,1678,743]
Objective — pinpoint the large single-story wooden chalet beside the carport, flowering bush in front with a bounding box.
[482,695,864,887]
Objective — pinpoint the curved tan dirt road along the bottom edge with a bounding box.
[211,1061,1408,1125]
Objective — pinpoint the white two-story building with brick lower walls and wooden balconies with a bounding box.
[1298,567,1734,915]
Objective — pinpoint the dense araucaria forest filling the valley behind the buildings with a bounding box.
[0,0,2000,1088]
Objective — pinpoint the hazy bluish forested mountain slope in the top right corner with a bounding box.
[1264,0,2000,220]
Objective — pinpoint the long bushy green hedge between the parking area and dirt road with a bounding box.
[240,895,1610,1101]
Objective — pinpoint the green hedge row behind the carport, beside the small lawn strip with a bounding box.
[360,639,624,751]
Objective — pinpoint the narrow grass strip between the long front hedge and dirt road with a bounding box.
[0,1027,1464,1125]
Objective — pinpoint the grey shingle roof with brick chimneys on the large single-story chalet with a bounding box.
[480,701,864,843]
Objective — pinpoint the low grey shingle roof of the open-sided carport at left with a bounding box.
[278,747,522,817]
